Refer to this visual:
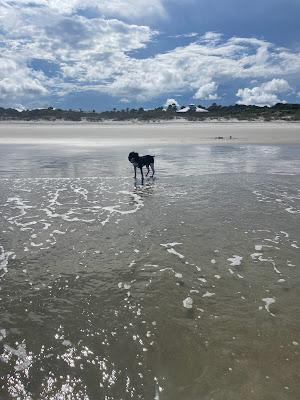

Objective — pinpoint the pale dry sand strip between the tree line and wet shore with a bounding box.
[0,122,300,147]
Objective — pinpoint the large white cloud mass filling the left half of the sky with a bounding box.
[0,2,156,105]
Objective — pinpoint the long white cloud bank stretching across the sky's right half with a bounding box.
[106,38,300,100]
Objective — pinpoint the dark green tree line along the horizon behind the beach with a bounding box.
[0,103,300,122]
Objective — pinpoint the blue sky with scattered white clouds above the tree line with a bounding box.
[0,0,300,111]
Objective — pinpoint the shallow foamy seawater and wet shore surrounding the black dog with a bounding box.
[0,145,300,400]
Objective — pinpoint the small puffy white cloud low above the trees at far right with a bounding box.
[236,79,290,106]
